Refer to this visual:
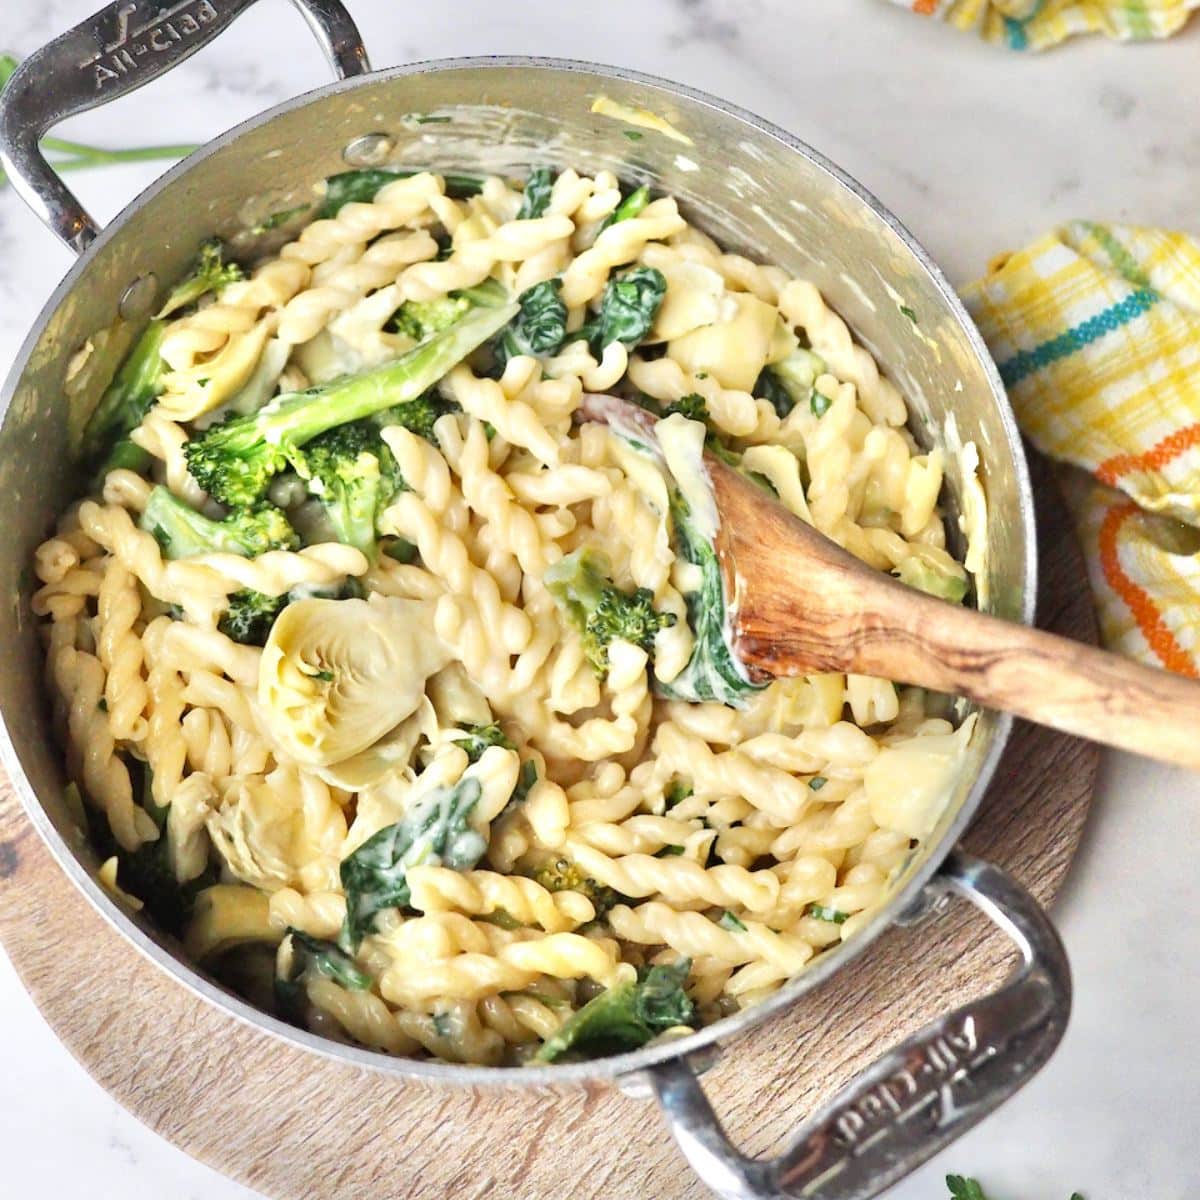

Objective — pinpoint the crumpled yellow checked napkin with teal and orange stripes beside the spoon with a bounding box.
[964,221,1200,677]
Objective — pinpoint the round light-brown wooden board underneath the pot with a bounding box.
[0,453,1099,1200]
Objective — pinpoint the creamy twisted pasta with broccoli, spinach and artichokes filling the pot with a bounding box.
[34,168,972,1064]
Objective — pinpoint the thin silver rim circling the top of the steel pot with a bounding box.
[0,55,1037,1087]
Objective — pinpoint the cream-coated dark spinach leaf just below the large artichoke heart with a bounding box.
[340,779,487,949]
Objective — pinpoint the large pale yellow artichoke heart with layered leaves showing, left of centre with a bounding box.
[258,595,450,767]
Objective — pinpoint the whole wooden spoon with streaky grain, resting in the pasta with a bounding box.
[584,397,1200,768]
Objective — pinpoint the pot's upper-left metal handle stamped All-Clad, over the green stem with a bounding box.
[0,0,370,254]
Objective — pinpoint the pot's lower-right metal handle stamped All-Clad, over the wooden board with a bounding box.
[646,852,1070,1200]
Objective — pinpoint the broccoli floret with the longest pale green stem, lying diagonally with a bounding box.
[186,305,517,508]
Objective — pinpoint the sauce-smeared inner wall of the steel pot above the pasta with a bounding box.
[0,60,1032,1003]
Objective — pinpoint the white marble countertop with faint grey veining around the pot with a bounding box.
[0,0,1200,1200]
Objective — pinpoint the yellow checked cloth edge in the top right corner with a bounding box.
[893,0,1200,50]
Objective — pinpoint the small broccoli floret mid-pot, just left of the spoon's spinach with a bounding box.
[545,547,676,676]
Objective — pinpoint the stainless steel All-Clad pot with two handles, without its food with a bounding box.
[0,0,1070,1200]
